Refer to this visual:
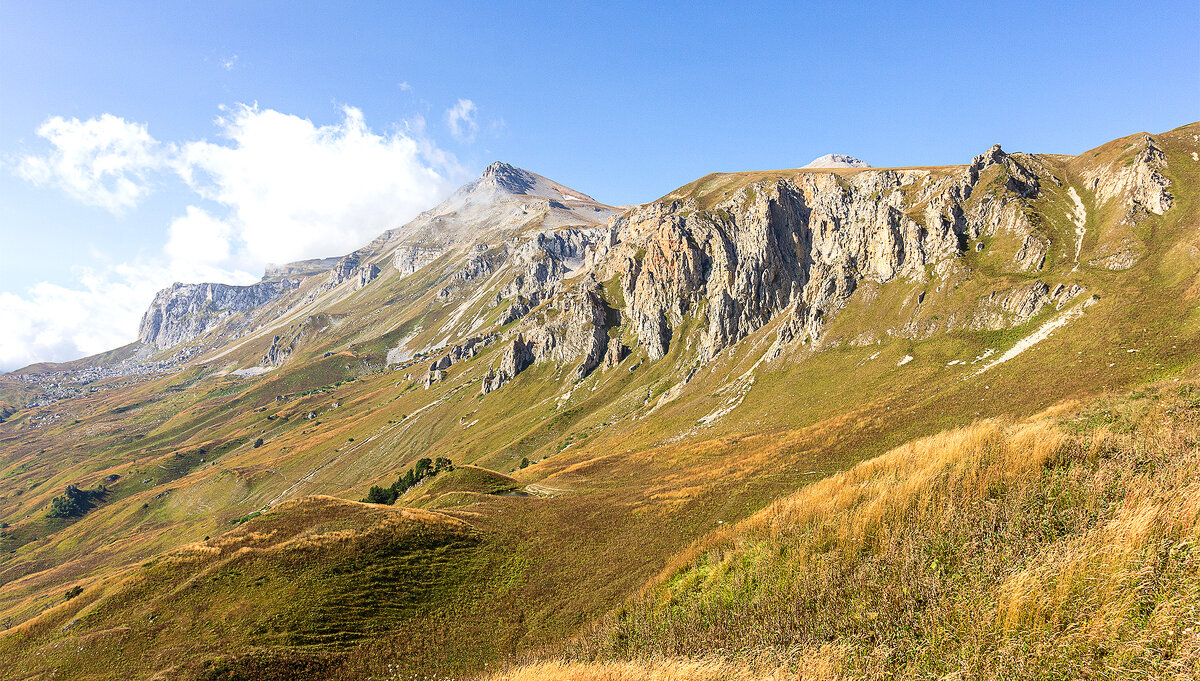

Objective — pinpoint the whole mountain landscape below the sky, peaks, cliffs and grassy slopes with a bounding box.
[0,123,1200,679]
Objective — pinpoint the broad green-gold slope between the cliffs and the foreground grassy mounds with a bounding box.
[0,121,1200,669]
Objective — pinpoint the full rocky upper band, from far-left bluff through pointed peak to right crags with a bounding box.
[126,128,1172,392]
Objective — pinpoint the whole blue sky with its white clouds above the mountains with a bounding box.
[0,0,1200,369]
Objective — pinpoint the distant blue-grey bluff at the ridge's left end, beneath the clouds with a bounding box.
[138,279,300,348]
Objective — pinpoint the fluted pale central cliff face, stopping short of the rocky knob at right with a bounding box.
[604,171,964,360]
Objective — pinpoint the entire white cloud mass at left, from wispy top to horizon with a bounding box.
[0,100,478,370]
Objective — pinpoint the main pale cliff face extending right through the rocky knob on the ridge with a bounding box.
[588,145,1089,361]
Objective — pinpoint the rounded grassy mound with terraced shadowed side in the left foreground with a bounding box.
[0,496,523,679]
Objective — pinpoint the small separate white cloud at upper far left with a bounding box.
[17,114,164,215]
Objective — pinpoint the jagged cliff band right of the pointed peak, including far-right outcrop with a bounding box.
[472,137,1171,391]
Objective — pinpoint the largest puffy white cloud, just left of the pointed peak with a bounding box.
[178,106,461,265]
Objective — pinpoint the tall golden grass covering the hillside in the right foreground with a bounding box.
[487,387,1200,680]
